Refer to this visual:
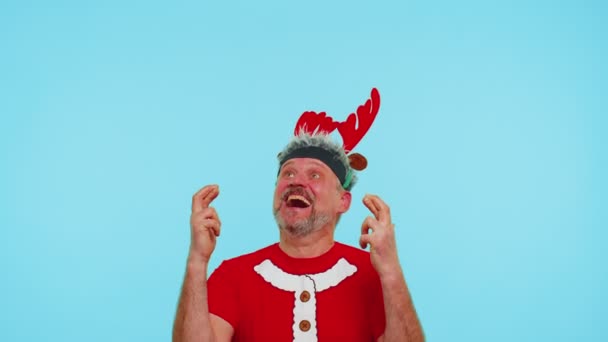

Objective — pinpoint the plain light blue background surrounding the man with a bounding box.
[0,0,608,341]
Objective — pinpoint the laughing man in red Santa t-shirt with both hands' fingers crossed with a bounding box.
[173,89,424,342]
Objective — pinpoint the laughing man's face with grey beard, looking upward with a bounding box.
[273,158,351,236]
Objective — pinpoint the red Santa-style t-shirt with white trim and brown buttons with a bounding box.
[207,242,385,342]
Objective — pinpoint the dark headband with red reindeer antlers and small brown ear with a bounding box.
[278,88,380,189]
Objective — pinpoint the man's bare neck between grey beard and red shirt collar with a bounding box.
[279,226,334,258]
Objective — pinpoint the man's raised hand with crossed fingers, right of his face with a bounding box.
[359,195,401,277]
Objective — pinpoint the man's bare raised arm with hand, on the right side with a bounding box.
[359,195,424,342]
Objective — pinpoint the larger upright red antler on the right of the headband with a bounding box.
[338,88,380,153]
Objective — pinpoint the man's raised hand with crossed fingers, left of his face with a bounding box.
[188,185,222,263]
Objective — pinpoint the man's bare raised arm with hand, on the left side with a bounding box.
[173,186,234,342]
